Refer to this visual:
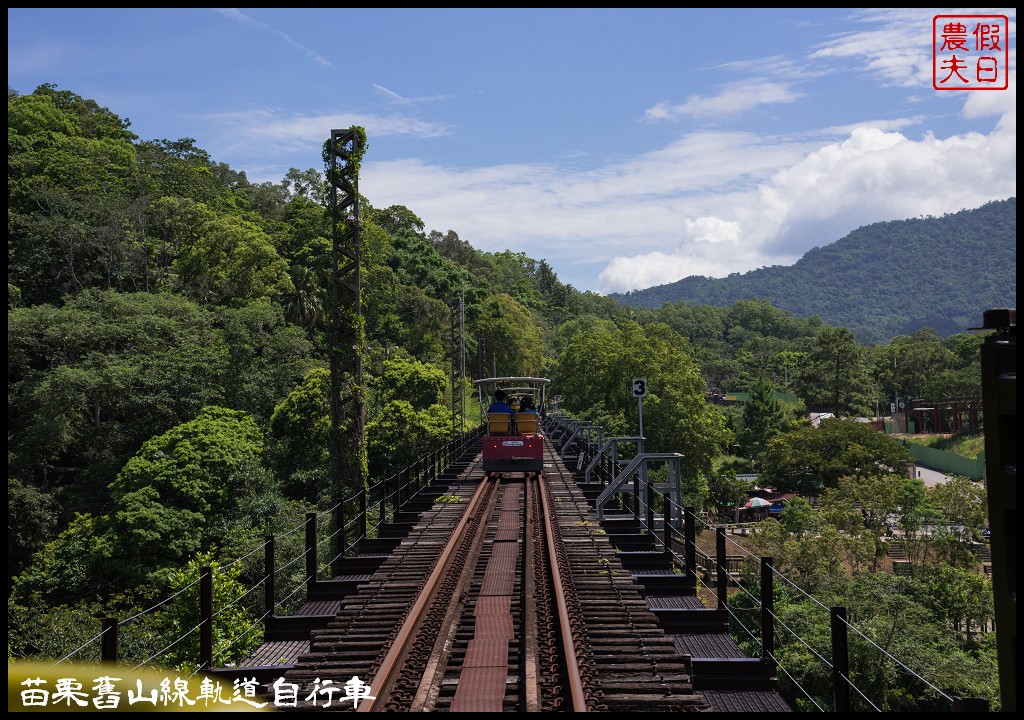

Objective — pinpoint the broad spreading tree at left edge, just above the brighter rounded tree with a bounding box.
[7,291,229,512]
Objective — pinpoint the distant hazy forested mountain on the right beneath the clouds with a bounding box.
[609,198,1017,344]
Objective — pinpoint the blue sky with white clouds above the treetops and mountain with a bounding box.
[7,8,1017,293]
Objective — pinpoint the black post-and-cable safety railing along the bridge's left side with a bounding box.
[48,426,483,674]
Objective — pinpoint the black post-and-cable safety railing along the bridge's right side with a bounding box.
[549,417,988,712]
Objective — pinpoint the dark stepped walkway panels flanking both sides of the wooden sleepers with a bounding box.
[213,430,792,712]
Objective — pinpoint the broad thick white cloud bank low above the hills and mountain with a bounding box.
[360,83,1016,293]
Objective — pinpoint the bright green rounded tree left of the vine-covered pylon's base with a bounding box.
[13,406,263,604]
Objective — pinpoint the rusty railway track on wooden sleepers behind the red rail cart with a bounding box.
[279,443,709,712]
